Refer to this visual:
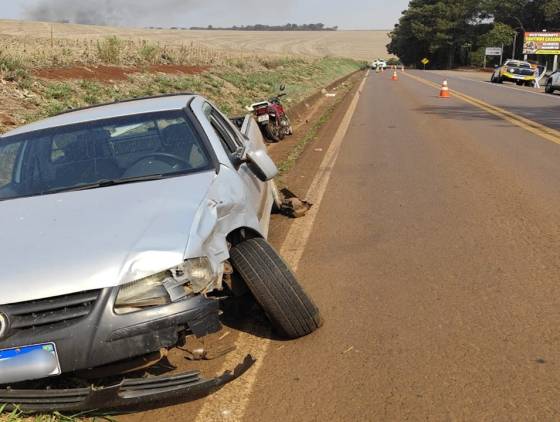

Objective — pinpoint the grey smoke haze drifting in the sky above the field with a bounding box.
[26,0,291,26]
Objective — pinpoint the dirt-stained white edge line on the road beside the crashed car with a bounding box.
[195,70,370,422]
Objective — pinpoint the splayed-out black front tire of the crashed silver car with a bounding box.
[230,238,323,339]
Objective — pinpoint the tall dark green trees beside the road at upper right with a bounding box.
[387,0,560,68]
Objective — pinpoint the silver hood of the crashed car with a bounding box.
[0,172,216,305]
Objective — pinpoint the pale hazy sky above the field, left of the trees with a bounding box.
[0,0,409,29]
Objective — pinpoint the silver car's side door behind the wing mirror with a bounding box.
[203,103,270,220]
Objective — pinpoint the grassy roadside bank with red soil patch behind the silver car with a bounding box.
[0,37,364,131]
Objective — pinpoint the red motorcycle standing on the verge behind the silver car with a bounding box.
[248,85,293,142]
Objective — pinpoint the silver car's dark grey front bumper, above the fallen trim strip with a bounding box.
[0,288,222,380]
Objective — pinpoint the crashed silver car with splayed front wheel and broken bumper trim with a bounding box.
[0,94,321,411]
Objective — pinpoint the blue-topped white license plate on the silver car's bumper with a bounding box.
[0,343,62,384]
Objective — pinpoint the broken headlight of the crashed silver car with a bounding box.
[114,258,219,315]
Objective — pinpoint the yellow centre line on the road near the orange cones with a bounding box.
[405,73,560,145]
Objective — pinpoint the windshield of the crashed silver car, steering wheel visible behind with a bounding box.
[0,111,212,200]
